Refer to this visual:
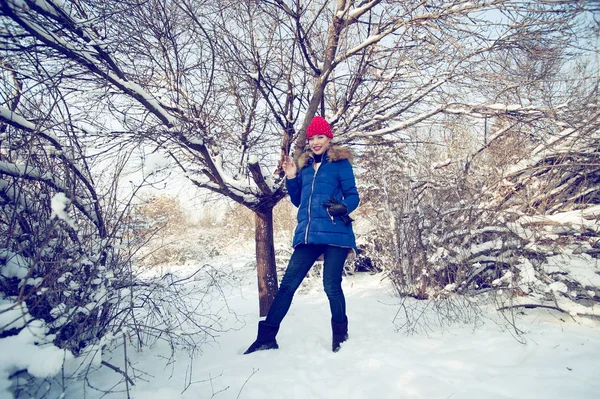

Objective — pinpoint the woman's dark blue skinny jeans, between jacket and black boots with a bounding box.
[265,244,348,324]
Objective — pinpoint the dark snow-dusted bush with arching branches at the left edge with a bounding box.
[0,129,129,392]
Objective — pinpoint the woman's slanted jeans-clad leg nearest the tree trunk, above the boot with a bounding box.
[265,245,325,325]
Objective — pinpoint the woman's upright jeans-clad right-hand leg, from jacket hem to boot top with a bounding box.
[323,245,348,323]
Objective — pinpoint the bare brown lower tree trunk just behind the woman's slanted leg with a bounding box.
[255,207,277,317]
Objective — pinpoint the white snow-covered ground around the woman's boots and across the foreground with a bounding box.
[66,252,600,399]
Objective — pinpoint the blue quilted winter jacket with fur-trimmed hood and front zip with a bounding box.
[286,146,360,253]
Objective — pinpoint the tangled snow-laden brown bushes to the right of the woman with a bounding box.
[360,106,600,322]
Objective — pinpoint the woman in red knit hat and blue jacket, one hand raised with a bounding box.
[245,116,359,354]
